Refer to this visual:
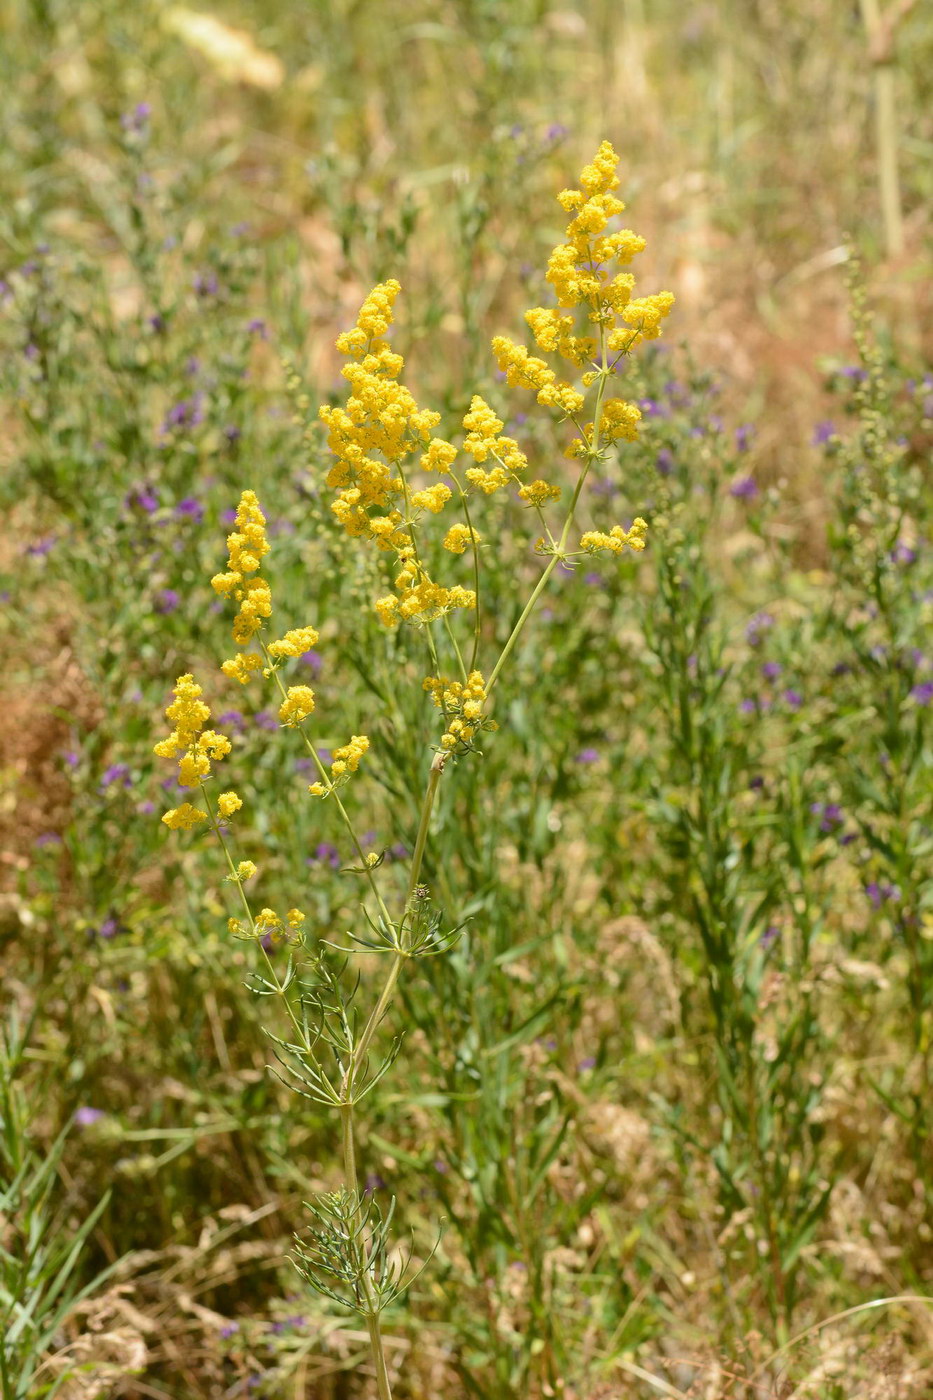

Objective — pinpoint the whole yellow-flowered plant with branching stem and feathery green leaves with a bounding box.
[156,141,674,1400]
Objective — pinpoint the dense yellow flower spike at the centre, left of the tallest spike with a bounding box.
[319,279,476,627]
